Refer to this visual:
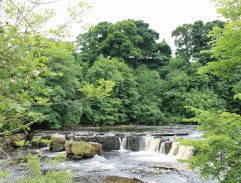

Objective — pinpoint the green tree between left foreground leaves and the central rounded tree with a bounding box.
[34,40,84,128]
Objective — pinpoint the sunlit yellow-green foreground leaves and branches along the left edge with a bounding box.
[0,0,112,134]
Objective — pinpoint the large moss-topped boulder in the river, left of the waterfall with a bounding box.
[65,141,102,159]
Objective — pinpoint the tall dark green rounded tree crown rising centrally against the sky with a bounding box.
[78,20,171,68]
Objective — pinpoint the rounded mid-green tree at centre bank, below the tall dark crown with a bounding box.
[82,58,138,125]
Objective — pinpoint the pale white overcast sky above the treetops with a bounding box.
[79,0,218,51]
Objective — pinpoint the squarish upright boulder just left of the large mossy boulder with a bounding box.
[49,134,66,152]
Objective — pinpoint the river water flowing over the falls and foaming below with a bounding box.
[1,125,217,183]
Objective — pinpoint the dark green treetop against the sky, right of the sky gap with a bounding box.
[172,20,224,61]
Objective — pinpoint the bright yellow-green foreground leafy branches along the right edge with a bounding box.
[183,0,241,183]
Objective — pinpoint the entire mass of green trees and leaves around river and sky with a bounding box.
[0,0,241,182]
